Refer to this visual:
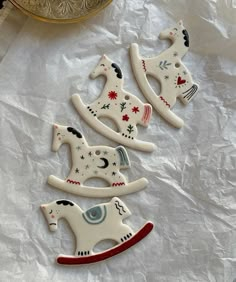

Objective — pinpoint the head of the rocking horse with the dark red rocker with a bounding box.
[41,200,75,231]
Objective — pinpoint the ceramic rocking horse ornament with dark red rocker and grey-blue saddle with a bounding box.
[41,197,153,265]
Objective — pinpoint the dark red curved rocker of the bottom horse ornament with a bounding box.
[57,222,153,265]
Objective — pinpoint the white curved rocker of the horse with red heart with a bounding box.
[130,43,184,128]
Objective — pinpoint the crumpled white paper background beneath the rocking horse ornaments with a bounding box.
[0,0,236,282]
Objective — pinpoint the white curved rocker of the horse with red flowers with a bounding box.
[71,94,156,152]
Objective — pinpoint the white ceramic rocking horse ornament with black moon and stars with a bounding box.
[48,124,148,197]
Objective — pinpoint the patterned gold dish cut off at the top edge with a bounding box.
[9,0,112,23]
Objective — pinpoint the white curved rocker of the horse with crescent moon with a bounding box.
[48,175,148,198]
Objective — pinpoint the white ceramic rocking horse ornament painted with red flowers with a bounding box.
[72,55,155,152]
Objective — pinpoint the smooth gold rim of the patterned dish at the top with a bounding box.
[9,0,112,24]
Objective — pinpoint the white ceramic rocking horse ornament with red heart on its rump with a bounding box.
[130,21,198,128]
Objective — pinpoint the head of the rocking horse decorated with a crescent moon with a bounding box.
[52,124,86,151]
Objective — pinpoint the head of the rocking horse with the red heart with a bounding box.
[159,21,189,47]
